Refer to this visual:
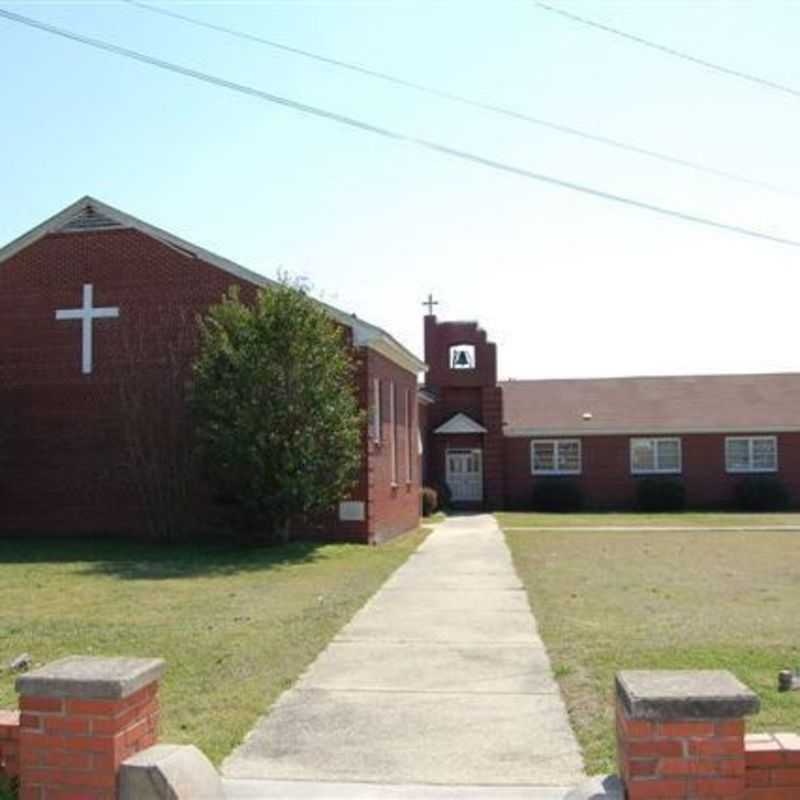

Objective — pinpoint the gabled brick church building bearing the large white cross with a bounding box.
[0,197,425,542]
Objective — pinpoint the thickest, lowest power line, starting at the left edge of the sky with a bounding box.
[0,8,800,247]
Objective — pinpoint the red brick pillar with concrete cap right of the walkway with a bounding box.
[616,670,759,800]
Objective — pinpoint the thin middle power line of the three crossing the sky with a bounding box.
[123,0,797,197]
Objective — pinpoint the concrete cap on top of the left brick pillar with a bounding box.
[16,656,165,700]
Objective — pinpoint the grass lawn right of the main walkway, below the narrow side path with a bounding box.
[506,530,800,774]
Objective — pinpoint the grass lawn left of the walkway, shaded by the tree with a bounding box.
[0,530,425,763]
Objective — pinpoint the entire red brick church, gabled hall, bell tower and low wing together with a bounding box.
[0,197,800,543]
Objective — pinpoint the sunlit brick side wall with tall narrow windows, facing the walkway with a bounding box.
[366,351,422,543]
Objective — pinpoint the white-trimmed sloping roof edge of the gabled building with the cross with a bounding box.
[0,195,427,373]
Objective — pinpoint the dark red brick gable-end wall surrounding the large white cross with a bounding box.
[0,229,418,539]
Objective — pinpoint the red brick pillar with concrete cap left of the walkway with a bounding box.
[17,656,164,800]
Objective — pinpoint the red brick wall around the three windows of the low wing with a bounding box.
[504,431,800,509]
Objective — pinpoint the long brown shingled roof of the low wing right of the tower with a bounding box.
[500,373,800,436]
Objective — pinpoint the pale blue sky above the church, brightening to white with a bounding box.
[0,0,800,378]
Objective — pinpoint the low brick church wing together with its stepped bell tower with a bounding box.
[421,314,800,509]
